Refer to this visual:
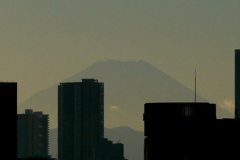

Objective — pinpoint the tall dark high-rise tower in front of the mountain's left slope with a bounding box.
[58,79,104,160]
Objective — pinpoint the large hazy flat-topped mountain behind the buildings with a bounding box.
[18,60,233,131]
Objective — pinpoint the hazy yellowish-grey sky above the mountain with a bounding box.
[0,0,240,112]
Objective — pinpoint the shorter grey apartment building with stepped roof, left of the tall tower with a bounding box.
[17,109,49,158]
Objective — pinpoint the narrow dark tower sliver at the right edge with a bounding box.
[235,49,240,118]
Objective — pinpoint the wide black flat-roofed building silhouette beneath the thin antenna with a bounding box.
[143,103,240,160]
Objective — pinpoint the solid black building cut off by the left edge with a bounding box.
[0,82,17,159]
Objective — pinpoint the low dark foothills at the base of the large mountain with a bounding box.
[49,126,144,160]
